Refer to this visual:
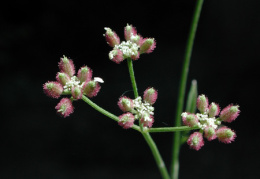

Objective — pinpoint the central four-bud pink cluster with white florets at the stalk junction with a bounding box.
[118,88,158,129]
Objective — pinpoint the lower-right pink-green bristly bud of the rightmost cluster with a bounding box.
[216,126,236,144]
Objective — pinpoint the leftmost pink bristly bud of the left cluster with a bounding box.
[43,81,63,98]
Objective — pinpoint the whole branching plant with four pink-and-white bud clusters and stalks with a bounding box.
[43,21,240,178]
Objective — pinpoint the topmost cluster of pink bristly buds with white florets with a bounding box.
[104,24,156,64]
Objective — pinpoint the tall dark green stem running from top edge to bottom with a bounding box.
[171,0,204,179]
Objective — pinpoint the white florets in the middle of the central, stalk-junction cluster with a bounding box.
[133,96,154,121]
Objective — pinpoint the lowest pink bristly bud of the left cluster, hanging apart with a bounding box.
[55,98,74,118]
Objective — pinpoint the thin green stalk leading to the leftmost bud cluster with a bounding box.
[82,95,140,132]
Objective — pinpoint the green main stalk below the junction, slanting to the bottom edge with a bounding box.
[142,132,170,179]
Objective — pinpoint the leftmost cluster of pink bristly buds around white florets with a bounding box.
[43,56,104,117]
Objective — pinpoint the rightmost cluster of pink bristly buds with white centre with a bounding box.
[181,95,240,150]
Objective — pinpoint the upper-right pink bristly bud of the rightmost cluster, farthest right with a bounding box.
[219,104,240,122]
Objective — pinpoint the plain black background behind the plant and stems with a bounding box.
[0,0,260,179]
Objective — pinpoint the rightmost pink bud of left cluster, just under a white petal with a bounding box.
[82,80,101,98]
